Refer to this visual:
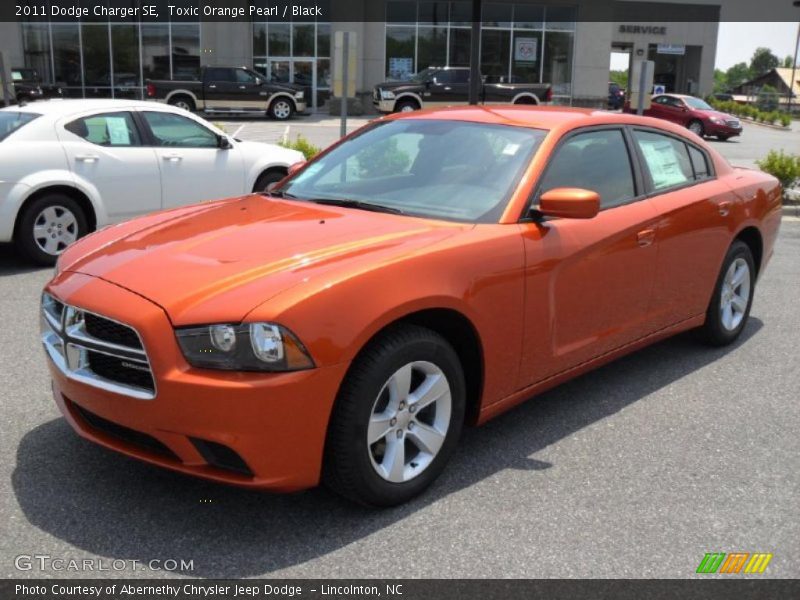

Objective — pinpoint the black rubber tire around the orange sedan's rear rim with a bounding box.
[699,240,756,346]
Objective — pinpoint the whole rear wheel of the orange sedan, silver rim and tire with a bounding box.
[702,240,755,346]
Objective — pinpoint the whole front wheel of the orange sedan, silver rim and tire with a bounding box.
[323,325,466,506]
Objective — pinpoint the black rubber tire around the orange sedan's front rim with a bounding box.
[323,325,466,506]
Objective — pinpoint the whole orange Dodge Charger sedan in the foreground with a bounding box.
[42,106,781,506]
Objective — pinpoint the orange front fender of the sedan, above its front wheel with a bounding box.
[246,225,524,405]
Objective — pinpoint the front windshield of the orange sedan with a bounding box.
[280,119,546,223]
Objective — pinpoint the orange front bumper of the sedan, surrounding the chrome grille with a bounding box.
[47,273,347,491]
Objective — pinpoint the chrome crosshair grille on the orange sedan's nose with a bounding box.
[41,293,156,400]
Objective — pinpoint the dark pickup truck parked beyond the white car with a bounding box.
[145,67,306,121]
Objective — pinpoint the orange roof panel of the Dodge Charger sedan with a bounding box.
[383,104,672,130]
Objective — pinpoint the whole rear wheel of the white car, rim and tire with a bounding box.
[15,194,87,265]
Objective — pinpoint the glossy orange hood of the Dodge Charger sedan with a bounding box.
[61,195,464,325]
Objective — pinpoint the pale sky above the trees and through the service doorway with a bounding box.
[611,23,797,71]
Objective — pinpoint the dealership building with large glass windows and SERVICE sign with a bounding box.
[0,0,788,109]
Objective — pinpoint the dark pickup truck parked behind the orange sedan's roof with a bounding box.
[372,67,553,113]
